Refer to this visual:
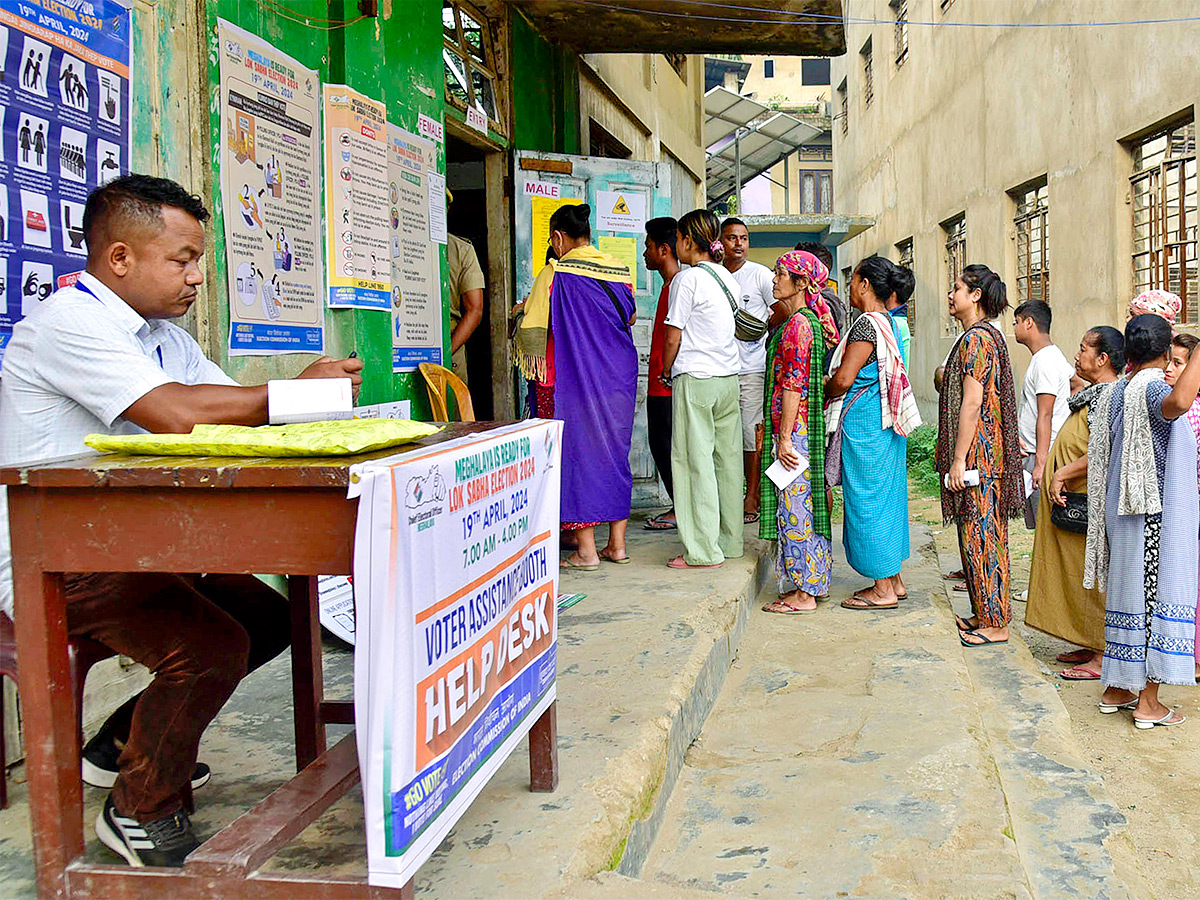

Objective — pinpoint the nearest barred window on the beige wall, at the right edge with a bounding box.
[1129,119,1198,322]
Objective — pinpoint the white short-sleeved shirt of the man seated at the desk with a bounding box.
[0,272,236,616]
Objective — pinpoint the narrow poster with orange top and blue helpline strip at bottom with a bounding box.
[325,84,391,310]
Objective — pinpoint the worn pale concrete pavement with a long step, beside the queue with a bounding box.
[0,513,1150,900]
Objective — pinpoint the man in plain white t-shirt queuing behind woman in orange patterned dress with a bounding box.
[1014,300,1075,528]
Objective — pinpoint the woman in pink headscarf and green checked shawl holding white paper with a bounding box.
[760,251,838,616]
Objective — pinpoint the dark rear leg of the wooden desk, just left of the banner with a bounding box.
[288,575,326,772]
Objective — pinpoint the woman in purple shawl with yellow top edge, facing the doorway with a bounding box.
[517,204,637,571]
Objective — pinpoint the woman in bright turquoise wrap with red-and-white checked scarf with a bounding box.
[826,257,920,610]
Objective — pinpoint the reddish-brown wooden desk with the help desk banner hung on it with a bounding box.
[0,422,558,900]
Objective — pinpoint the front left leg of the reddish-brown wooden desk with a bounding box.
[10,566,83,900]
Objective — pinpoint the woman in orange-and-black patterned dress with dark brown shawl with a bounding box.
[935,265,1025,647]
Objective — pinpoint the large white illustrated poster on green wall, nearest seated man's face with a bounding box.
[217,19,325,356]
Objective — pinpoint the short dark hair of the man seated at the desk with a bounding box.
[83,175,209,253]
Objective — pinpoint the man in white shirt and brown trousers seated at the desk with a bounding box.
[0,175,362,866]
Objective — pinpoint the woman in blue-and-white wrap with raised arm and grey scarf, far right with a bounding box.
[1084,313,1200,728]
